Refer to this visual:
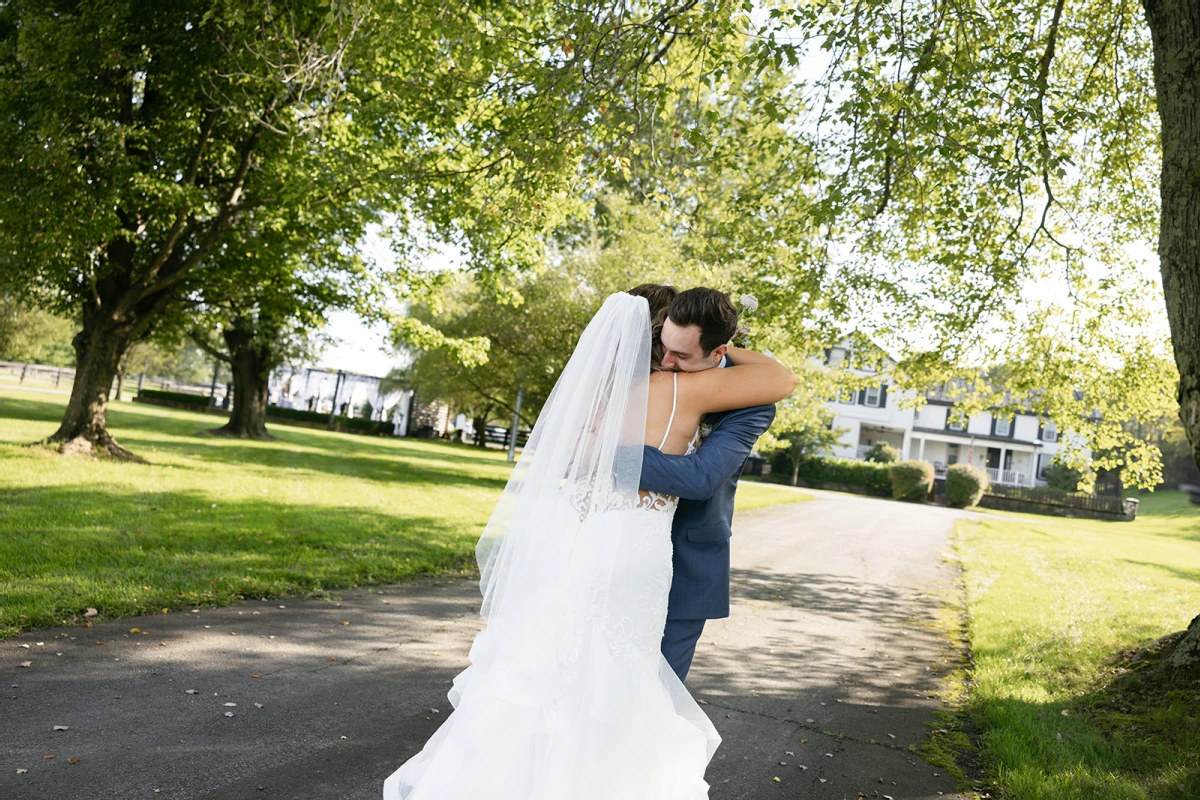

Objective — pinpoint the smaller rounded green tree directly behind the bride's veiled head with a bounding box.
[408,193,709,431]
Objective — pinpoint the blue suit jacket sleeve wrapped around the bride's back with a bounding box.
[642,405,775,500]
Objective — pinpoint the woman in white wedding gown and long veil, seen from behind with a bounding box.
[383,293,796,800]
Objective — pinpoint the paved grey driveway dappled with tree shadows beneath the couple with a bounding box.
[0,493,974,800]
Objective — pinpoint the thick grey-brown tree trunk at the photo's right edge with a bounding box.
[1144,0,1200,652]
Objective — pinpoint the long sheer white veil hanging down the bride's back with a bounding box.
[450,291,650,705]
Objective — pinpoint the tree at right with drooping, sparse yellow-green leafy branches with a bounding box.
[739,0,1200,695]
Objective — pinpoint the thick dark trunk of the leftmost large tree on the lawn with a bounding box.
[46,312,143,462]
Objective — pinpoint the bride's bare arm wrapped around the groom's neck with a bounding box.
[679,348,797,414]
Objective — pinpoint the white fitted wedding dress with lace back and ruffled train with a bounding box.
[383,295,720,800]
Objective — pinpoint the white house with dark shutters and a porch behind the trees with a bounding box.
[826,347,1089,486]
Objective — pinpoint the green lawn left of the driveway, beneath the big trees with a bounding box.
[0,387,809,638]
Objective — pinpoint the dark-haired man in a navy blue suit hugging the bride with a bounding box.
[642,287,775,680]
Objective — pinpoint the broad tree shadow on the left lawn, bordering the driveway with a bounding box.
[0,486,479,636]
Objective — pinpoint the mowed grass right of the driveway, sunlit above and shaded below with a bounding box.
[958,492,1200,800]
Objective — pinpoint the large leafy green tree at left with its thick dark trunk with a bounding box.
[0,0,743,456]
